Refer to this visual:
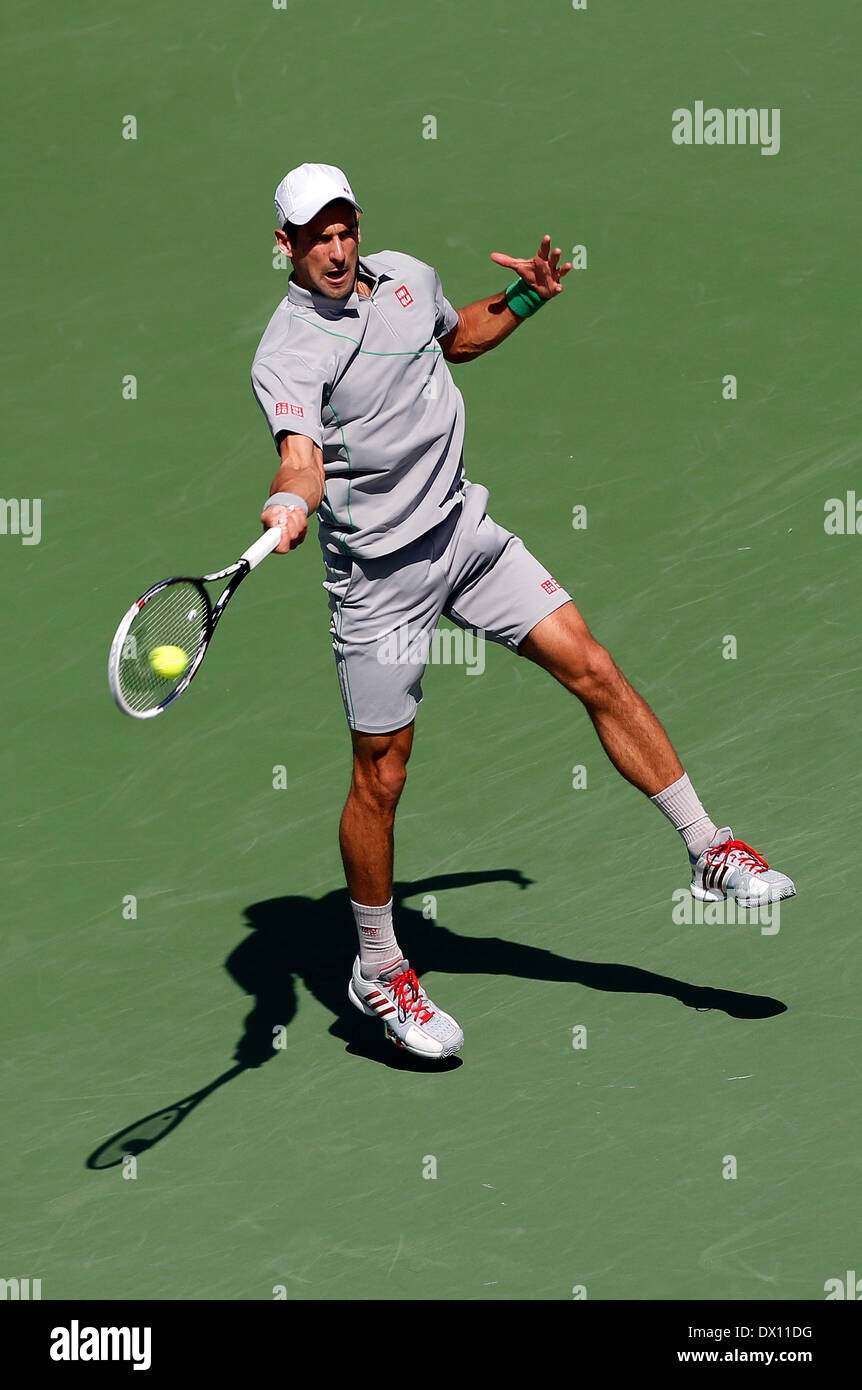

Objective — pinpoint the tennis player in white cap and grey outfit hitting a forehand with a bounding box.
[252,164,795,1059]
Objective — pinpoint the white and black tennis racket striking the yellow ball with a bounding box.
[108,527,281,719]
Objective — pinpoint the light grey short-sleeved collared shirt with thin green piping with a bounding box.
[252,252,464,557]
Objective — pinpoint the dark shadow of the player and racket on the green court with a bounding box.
[86,869,787,1169]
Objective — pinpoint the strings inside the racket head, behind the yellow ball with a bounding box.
[117,580,210,713]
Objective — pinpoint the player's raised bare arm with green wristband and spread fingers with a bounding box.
[438,236,571,363]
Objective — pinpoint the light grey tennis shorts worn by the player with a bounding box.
[324,481,570,734]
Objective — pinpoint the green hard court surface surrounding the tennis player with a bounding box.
[0,0,862,1301]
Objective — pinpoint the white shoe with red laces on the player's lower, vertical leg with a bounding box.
[348,956,464,1061]
